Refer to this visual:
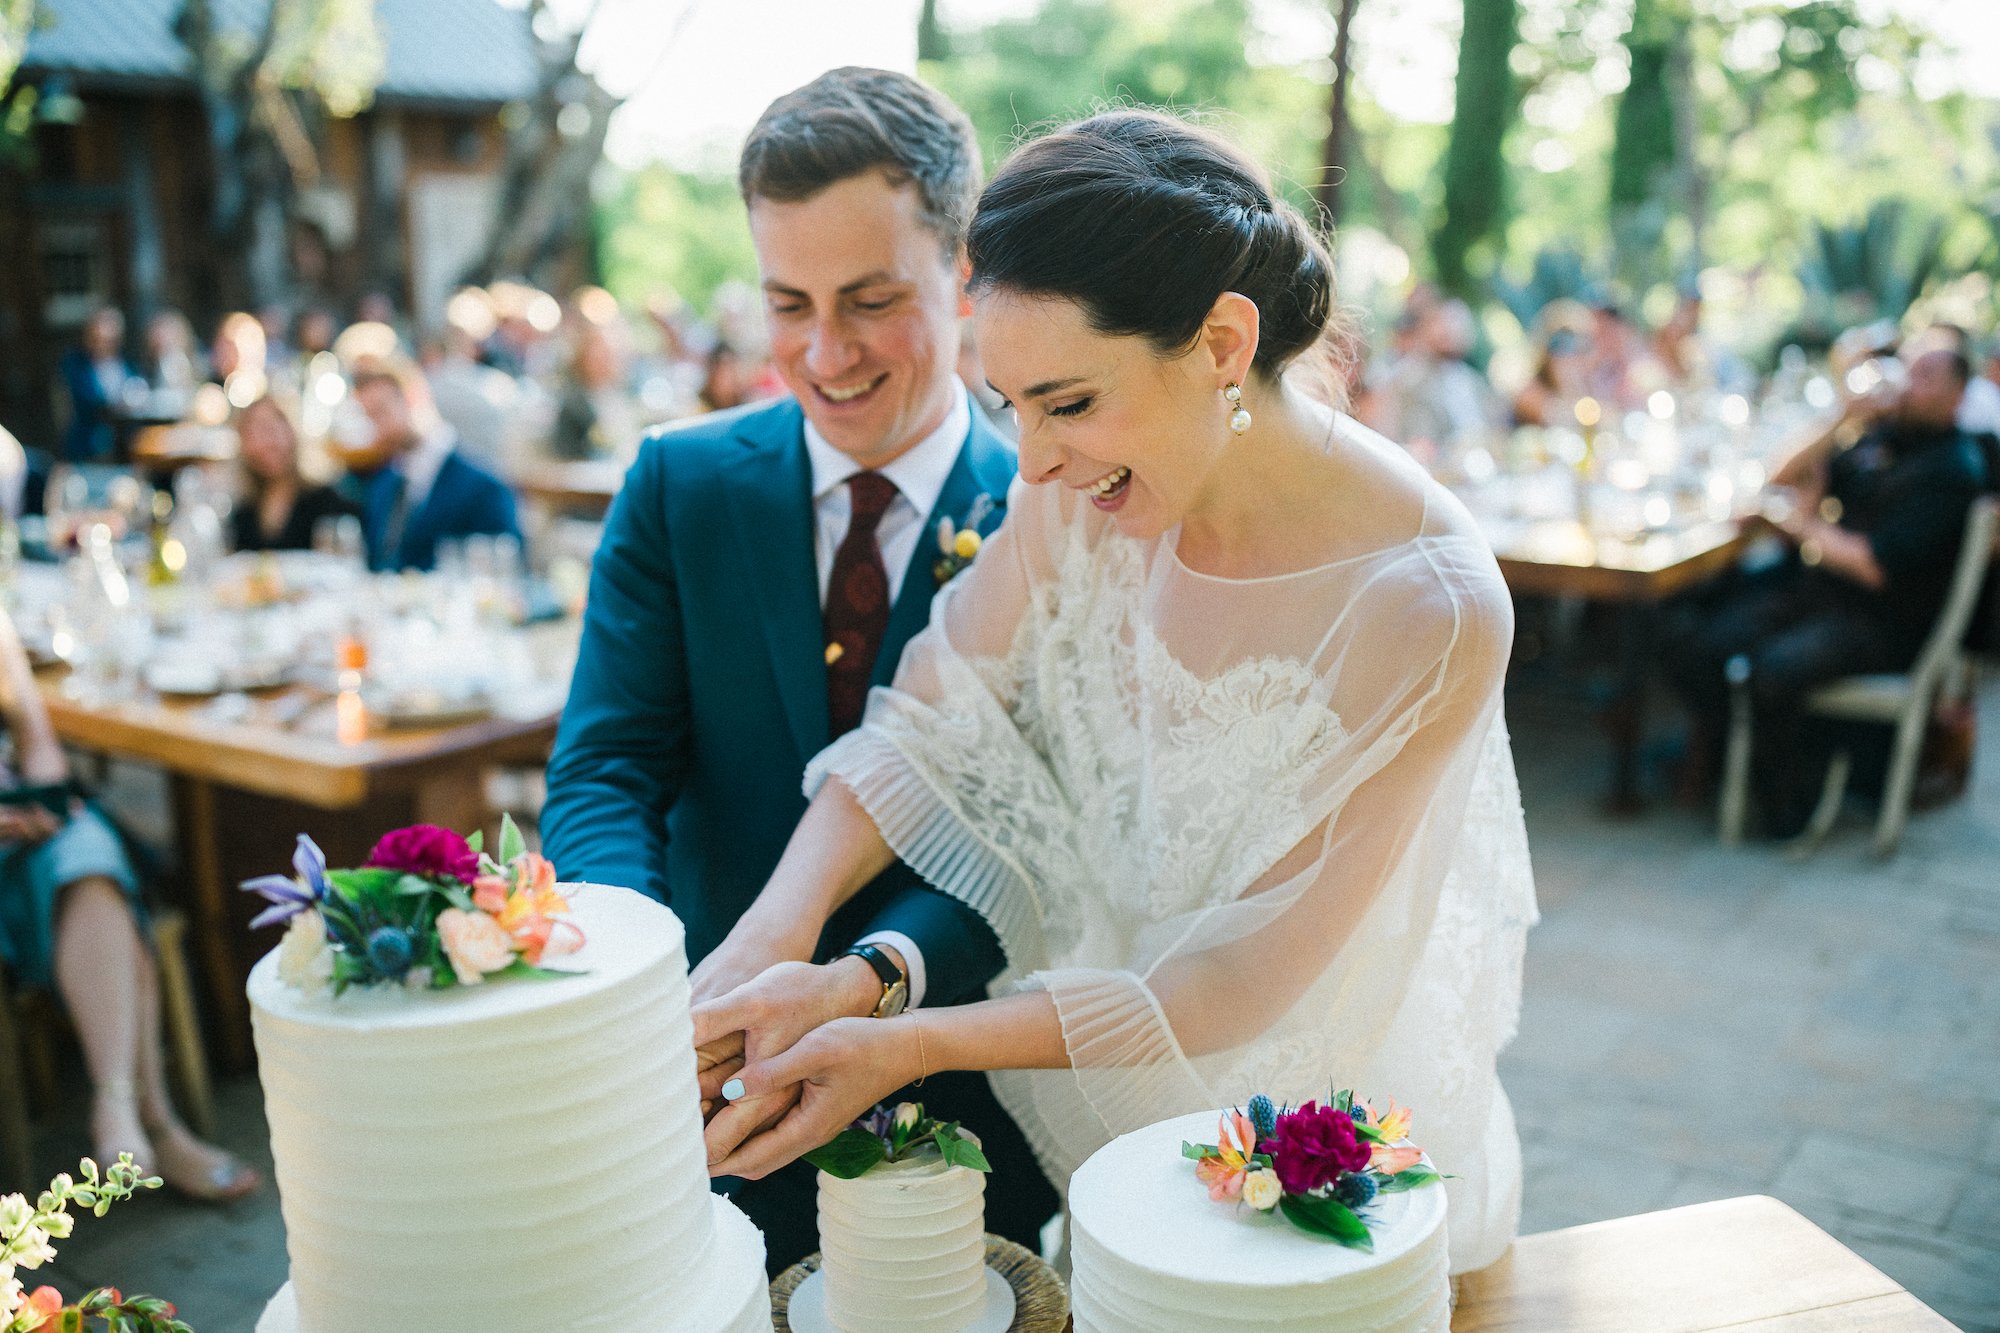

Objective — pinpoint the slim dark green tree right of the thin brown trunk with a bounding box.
[1430,0,1516,296]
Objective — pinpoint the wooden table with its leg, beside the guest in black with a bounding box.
[1490,518,1750,815]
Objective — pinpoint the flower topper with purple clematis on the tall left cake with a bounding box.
[242,817,584,984]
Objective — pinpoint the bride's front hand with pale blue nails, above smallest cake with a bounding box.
[706,1015,924,1181]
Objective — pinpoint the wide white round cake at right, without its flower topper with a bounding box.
[1070,1111,1450,1333]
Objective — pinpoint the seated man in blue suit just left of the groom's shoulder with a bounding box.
[354,358,520,570]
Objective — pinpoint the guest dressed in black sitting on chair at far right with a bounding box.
[1666,330,1986,837]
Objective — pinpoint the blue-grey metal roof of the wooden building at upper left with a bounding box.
[22,0,538,104]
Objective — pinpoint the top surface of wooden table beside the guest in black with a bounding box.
[1494,518,1748,602]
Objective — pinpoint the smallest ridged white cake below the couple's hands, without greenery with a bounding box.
[820,1151,986,1333]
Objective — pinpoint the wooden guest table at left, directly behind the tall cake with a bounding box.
[40,624,576,1069]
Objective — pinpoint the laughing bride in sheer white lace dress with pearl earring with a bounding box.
[696,110,1534,1271]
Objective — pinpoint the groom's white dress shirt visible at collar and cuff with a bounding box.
[806,380,972,1009]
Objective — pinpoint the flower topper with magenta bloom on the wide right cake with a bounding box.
[1180,1091,1444,1249]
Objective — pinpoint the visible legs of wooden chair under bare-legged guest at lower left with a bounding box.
[0,909,216,1193]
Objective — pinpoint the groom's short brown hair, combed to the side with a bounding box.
[736,66,980,254]
